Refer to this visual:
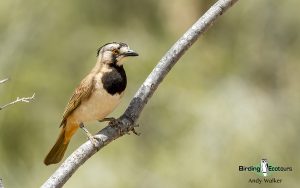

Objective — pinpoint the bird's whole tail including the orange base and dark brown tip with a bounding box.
[44,125,78,165]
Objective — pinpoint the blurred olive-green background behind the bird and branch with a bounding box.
[0,0,300,188]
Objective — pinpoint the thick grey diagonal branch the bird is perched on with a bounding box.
[42,0,238,188]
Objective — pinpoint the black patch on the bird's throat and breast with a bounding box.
[102,63,127,95]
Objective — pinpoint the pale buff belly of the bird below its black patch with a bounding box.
[73,89,122,123]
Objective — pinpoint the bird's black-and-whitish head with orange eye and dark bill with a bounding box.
[97,42,139,66]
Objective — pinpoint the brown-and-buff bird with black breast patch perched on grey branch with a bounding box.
[44,42,139,165]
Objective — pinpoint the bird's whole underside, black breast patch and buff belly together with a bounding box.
[73,64,127,123]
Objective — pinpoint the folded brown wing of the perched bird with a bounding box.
[60,76,94,127]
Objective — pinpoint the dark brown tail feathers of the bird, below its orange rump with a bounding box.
[44,128,70,165]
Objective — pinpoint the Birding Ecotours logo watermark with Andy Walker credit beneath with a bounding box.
[239,159,293,184]
